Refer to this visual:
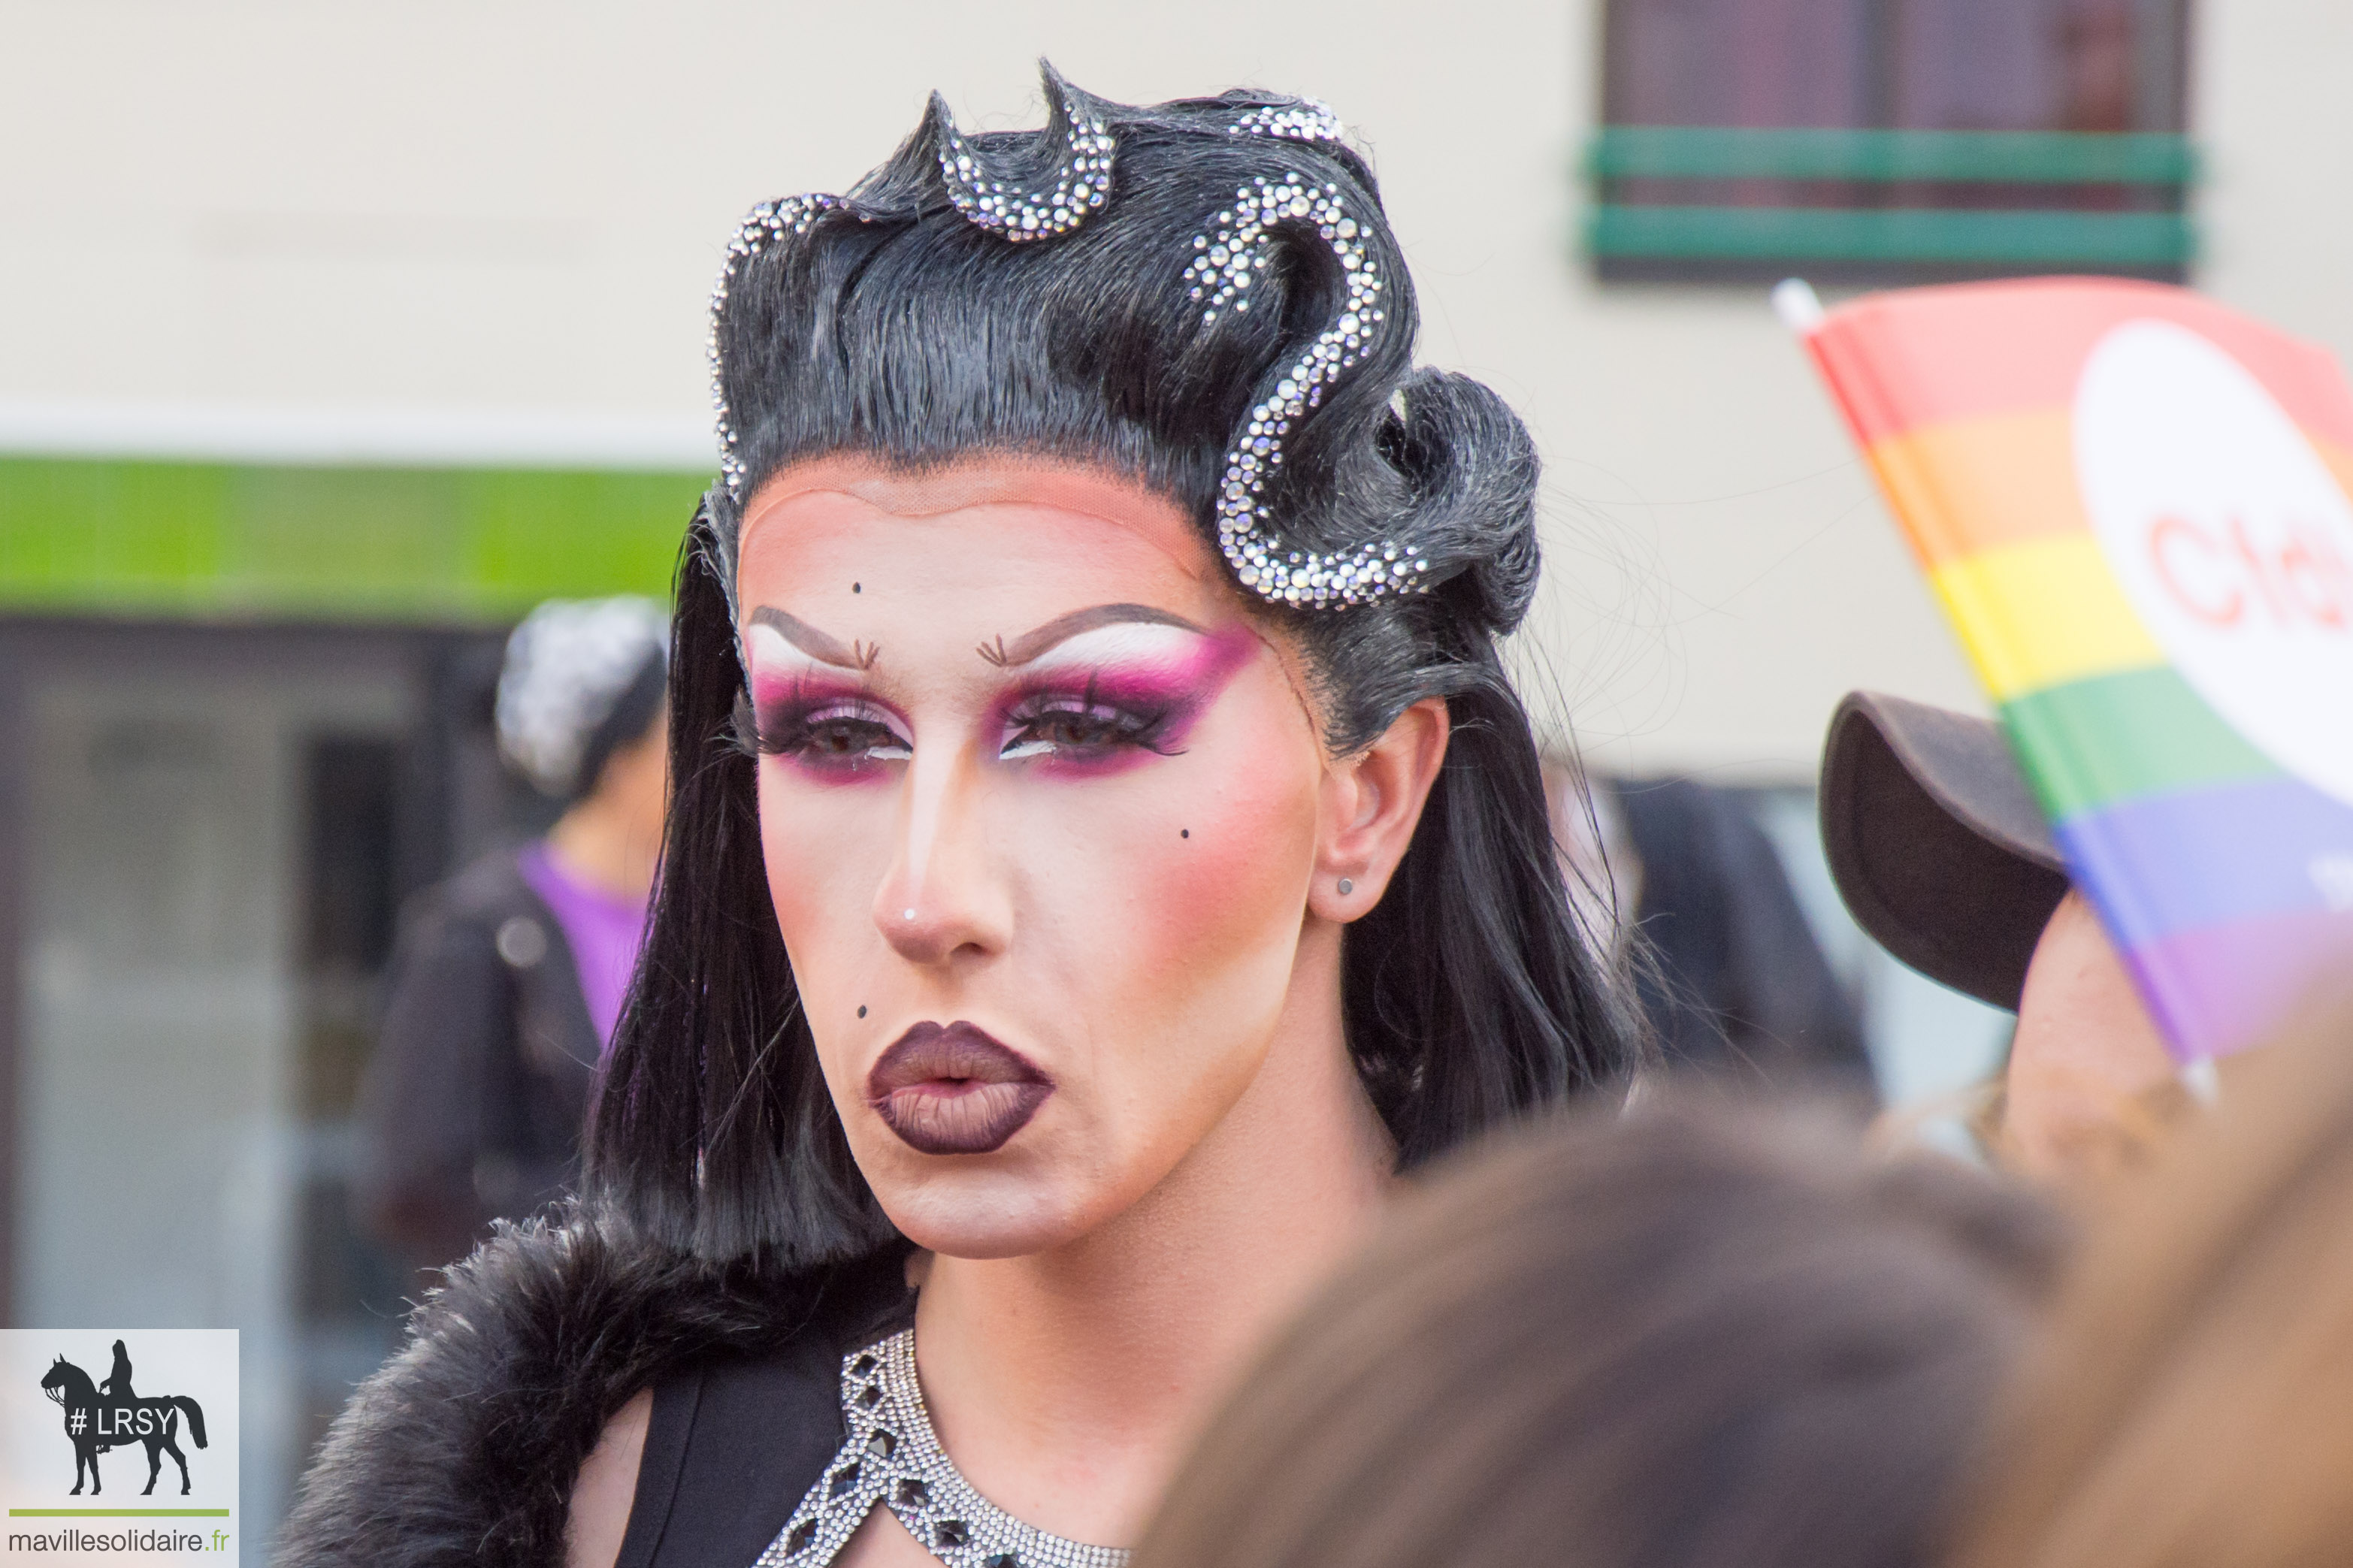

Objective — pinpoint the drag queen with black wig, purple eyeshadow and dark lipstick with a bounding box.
[283,71,1631,1568]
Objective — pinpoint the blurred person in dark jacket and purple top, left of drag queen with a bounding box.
[358,597,668,1267]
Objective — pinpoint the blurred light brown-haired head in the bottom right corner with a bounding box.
[1955,999,2353,1568]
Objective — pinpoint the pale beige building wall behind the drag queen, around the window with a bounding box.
[0,0,2353,778]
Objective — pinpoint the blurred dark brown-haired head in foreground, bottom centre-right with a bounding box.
[1134,1098,2059,1568]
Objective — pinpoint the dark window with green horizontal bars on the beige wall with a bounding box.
[1583,0,2195,282]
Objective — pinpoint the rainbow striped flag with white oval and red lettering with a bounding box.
[1800,277,2353,1060]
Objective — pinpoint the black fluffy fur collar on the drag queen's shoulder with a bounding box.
[275,1218,906,1568]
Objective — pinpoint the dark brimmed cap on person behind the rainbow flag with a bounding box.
[1821,691,2068,1011]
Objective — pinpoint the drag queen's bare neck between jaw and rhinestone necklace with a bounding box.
[915,922,1396,1545]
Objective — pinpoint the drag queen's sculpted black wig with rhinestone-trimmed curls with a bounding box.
[586,68,1635,1267]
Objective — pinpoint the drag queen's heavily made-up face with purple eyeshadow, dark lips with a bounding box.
[739,458,1364,1258]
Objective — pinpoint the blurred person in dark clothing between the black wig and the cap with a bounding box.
[1544,760,1878,1102]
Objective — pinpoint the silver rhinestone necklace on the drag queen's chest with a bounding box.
[753,1328,1127,1568]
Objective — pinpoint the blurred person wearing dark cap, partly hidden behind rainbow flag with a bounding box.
[1821,691,2186,1185]
